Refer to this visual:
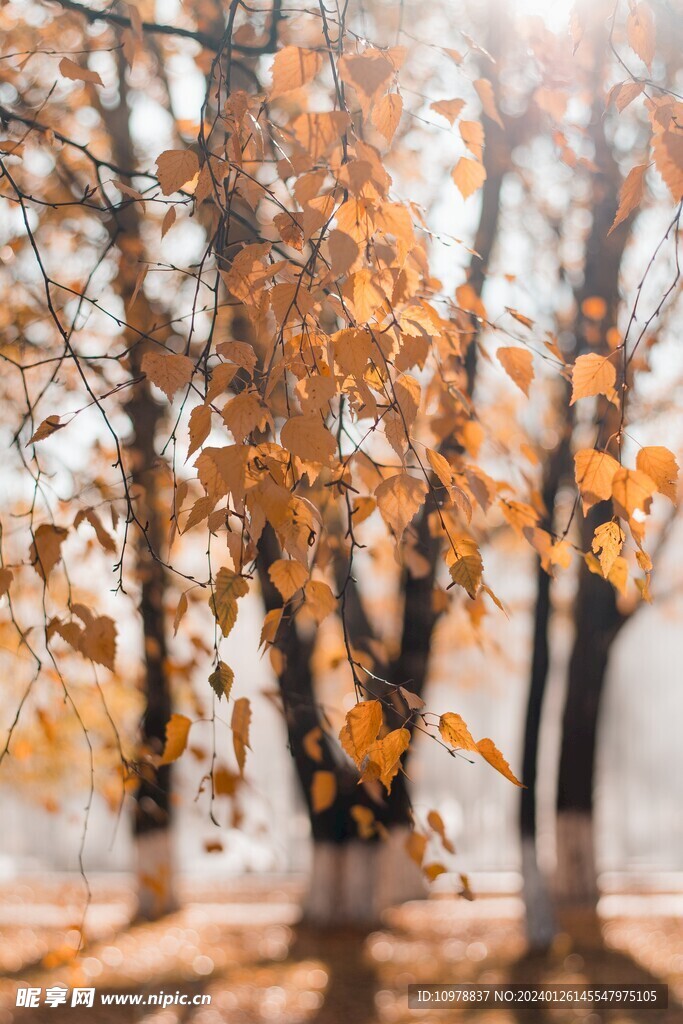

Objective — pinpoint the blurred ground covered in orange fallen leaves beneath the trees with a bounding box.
[0,878,683,1024]
